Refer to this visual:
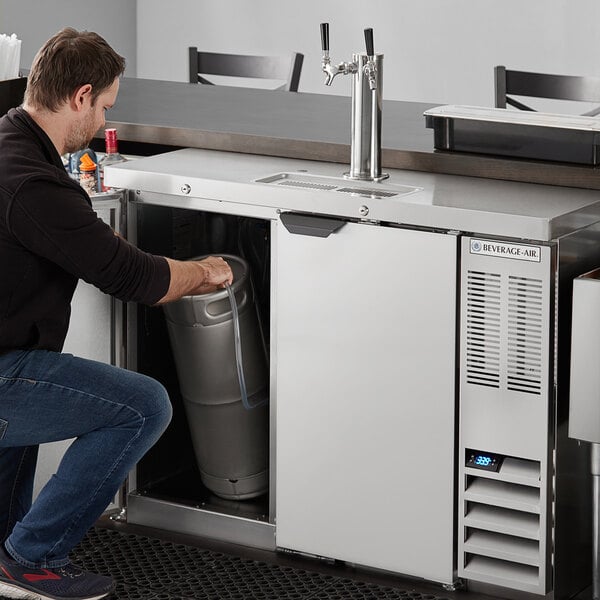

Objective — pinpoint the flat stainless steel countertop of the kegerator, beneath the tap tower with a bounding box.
[105,149,600,241]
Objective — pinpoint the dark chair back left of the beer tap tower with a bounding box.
[189,46,304,92]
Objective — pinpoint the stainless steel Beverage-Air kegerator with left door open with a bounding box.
[107,149,600,599]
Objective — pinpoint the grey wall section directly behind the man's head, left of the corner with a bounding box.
[0,0,136,77]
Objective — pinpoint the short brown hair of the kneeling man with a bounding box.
[25,27,125,112]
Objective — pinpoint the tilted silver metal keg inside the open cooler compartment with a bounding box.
[163,255,269,500]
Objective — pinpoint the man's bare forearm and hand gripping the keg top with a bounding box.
[157,256,233,304]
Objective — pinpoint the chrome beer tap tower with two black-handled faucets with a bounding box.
[321,23,389,181]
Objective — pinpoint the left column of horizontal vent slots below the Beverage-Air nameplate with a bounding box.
[467,271,501,388]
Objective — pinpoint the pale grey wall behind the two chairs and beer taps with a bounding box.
[137,0,600,106]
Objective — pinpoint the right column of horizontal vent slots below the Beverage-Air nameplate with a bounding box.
[506,276,543,394]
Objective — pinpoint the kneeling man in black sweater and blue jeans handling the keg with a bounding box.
[0,28,232,600]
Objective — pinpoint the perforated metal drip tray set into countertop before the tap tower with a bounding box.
[255,173,423,199]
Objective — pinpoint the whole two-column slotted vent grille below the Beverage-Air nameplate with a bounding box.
[465,270,545,395]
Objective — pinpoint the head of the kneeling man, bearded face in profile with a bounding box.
[23,27,125,153]
